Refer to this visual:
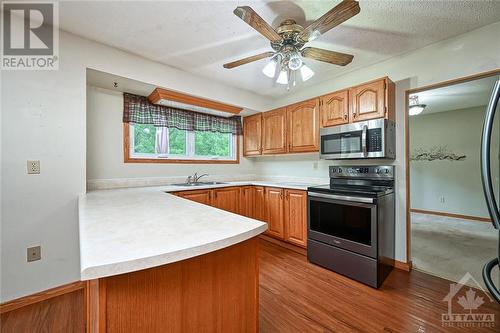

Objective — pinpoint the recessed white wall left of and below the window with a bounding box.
[87,86,254,180]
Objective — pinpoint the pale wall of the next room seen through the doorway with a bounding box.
[409,106,500,217]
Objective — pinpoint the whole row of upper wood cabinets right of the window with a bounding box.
[243,77,396,152]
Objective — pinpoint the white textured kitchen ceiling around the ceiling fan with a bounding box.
[59,0,500,97]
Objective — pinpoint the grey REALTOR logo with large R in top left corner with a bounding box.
[0,1,59,70]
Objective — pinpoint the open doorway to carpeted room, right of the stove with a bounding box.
[407,73,500,286]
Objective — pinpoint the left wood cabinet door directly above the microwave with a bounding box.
[319,90,349,127]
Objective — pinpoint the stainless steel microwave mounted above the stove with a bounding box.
[320,119,396,160]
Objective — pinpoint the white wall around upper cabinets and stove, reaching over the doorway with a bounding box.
[256,22,500,261]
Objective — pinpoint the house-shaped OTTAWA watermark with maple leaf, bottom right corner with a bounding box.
[441,273,495,328]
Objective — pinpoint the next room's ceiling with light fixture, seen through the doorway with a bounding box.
[411,75,500,115]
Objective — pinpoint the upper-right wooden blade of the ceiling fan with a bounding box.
[297,0,361,43]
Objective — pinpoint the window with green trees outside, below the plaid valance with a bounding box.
[124,123,238,163]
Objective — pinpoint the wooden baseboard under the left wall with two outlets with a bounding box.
[0,281,86,314]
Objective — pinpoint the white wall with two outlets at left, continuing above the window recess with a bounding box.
[0,21,269,302]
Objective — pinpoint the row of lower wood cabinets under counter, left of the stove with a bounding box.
[173,186,307,247]
